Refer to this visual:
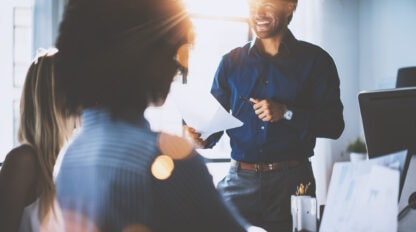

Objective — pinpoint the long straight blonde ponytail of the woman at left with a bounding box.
[18,50,66,221]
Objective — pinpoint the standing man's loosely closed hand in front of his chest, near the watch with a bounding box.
[250,98,286,122]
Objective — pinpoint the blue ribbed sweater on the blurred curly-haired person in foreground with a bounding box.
[56,109,247,232]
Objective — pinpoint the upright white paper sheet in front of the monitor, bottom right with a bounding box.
[319,151,407,232]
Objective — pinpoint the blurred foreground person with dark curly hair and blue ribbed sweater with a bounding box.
[56,0,258,232]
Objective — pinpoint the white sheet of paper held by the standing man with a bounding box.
[170,84,243,139]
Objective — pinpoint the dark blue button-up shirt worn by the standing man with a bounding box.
[207,31,344,162]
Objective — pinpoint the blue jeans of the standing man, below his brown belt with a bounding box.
[217,162,316,232]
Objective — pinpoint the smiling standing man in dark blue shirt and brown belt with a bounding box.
[185,0,344,231]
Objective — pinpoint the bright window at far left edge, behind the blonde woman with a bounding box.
[0,0,33,163]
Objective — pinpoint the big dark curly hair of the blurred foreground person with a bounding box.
[55,0,193,116]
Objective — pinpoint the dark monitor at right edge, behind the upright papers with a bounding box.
[358,87,416,158]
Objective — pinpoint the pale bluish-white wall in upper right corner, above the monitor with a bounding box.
[359,0,416,90]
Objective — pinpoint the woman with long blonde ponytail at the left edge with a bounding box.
[0,50,74,231]
